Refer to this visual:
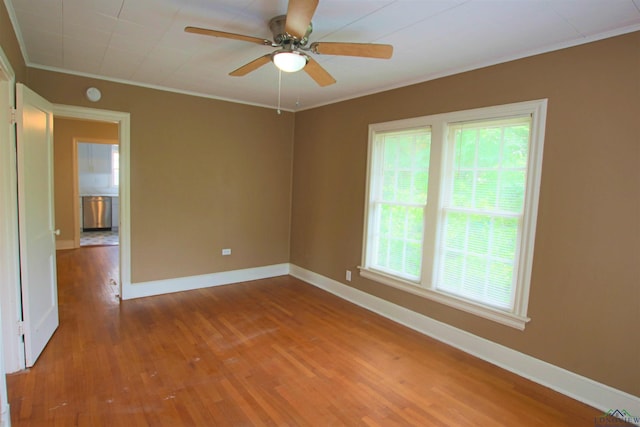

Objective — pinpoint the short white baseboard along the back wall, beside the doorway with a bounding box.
[122,264,289,299]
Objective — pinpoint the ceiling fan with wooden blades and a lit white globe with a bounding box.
[184,0,393,86]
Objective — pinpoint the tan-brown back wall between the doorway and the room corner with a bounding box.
[28,69,293,283]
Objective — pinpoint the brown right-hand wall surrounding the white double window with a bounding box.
[291,33,640,396]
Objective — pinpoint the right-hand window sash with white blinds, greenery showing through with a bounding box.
[435,115,531,309]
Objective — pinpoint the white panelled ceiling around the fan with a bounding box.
[5,0,640,111]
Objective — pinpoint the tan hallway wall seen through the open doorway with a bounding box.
[53,118,118,241]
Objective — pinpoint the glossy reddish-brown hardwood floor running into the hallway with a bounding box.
[7,246,601,427]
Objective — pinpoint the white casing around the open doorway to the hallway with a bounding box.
[53,104,131,298]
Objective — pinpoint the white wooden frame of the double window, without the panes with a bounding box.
[359,99,547,330]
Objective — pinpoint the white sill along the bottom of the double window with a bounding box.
[359,267,531,331]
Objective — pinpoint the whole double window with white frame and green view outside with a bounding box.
[360,100,546,329]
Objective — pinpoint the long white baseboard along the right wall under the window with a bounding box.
[289,264,640,425]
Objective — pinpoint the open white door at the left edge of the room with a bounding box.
[16,84,58,367]
